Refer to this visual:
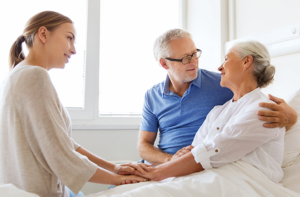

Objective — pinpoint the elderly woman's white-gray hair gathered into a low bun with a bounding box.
[232,41,275,88]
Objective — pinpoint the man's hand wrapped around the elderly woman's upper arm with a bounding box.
[257,94,298,131]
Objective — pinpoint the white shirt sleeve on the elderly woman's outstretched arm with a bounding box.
[192,110,285,169]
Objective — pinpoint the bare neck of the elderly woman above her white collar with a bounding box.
[230,79,257,101]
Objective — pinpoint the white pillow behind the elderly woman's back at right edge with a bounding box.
[282,90,300,168]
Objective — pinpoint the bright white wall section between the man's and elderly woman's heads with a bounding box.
[187,0,228,72]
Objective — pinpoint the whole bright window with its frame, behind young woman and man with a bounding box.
[0,0,186,125]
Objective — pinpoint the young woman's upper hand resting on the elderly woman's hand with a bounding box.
[114,163,153,175]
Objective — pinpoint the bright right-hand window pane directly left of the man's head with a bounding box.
[99,0,181,115]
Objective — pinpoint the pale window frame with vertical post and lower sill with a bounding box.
[67,0,187,129]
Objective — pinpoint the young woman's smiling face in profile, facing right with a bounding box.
[47,23,76,70]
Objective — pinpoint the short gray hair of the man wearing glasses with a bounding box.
[153,29,192,61]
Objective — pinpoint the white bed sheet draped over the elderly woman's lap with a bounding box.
[87,157,300,197]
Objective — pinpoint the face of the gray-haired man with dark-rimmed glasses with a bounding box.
[164,37,198,83]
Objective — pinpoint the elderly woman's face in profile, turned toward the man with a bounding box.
[218,50,243,89]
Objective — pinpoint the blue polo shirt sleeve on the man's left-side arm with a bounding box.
[140,91,159,132]
